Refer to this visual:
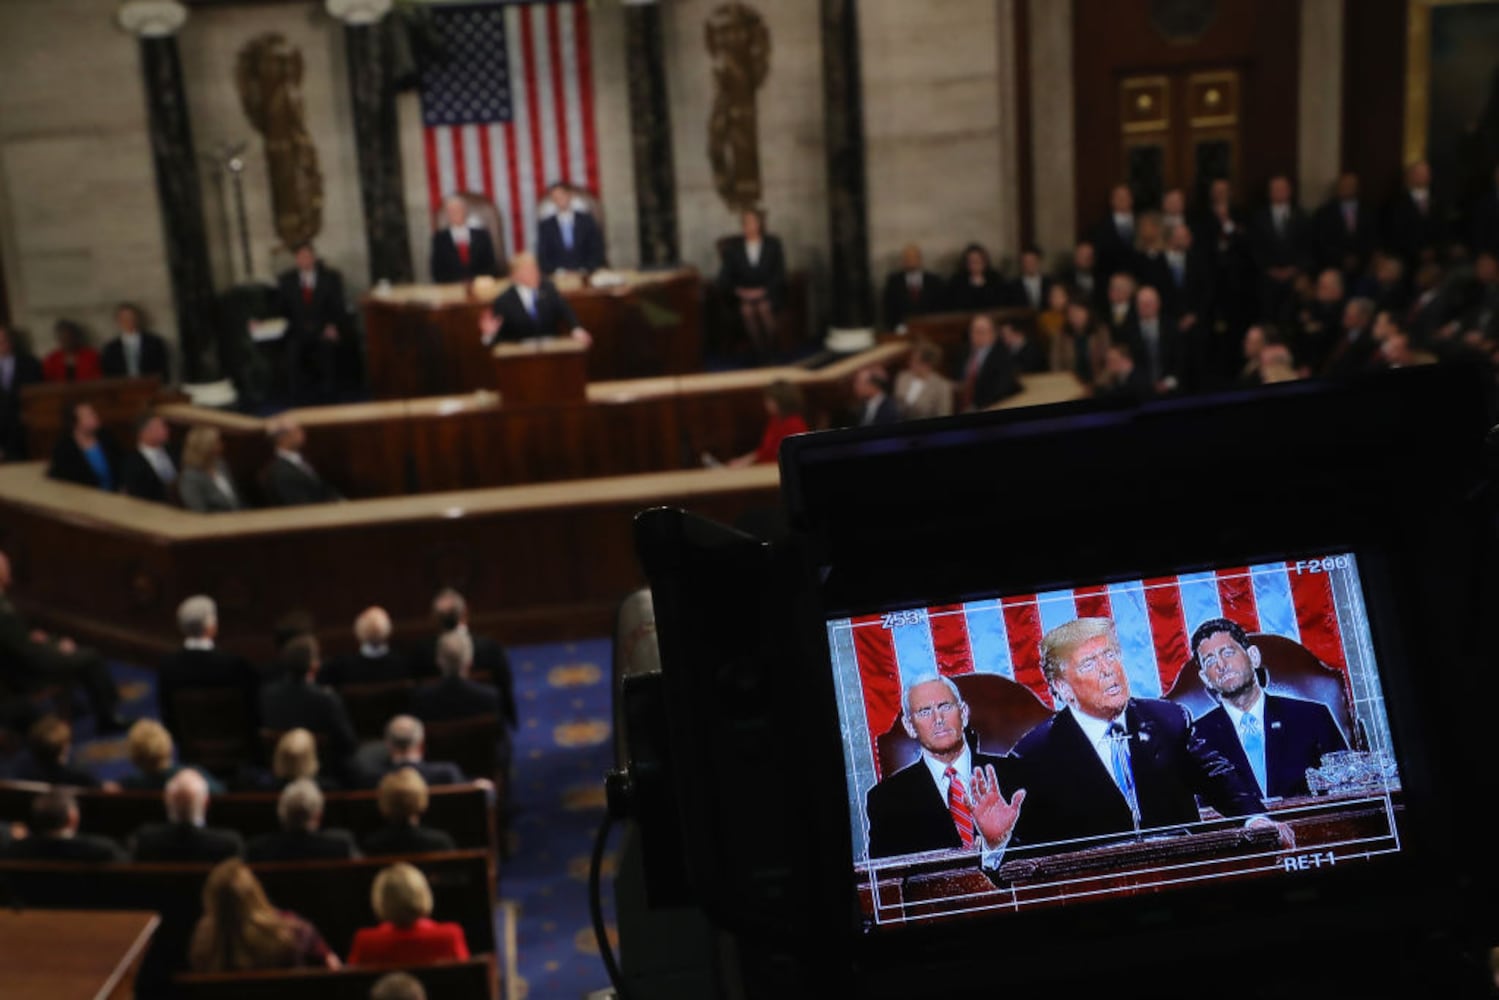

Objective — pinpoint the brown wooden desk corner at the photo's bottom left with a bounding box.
[0,910,160,1000]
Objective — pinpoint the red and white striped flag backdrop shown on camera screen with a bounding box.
[829,562,1361,768]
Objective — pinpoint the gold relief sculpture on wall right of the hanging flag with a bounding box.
[705,3,770,211]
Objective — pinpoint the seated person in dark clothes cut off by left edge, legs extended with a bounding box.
[0,552,124,735]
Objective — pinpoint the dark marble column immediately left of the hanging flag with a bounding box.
[327,0,415,285]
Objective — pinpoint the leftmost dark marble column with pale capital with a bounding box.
[118,0,219,382]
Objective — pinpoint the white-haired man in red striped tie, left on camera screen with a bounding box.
[865,676,1025,859]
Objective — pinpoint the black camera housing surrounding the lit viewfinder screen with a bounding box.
[613,369,1499,997]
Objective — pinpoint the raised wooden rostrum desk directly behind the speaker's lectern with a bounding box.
[361,268,703,399]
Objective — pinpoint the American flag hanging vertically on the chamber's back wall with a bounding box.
[421,1,598,262]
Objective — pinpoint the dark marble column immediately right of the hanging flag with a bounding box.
[625,0,681,267]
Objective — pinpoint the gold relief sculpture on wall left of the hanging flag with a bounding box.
[234,33,322,247]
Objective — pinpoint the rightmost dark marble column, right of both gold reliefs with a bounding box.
[821,0,874,330]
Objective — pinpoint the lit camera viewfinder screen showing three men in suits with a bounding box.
[827,553,1403,934]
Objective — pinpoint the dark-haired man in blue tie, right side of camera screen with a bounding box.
[1192,618,1348,799]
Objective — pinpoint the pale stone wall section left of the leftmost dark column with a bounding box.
[0,0,177,359]
